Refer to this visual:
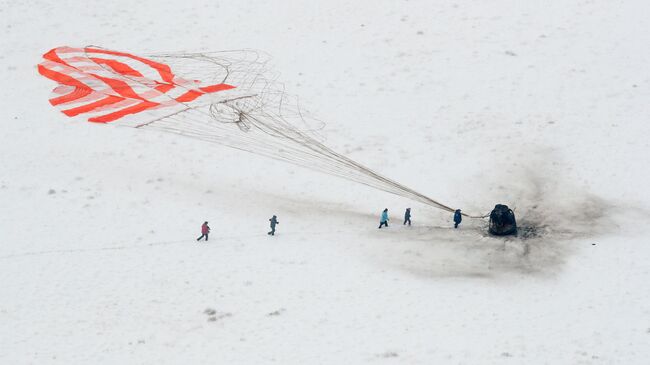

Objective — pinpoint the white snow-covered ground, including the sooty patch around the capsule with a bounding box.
[0,0,650,365]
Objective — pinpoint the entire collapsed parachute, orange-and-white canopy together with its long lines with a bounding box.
[39,46,474,217]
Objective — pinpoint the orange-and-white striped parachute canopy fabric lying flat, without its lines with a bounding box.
[38,47,235,123]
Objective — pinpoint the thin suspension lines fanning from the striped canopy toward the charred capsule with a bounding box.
[154,55,481,218]
